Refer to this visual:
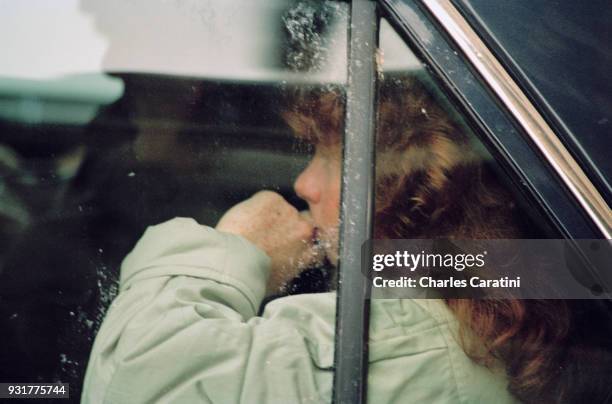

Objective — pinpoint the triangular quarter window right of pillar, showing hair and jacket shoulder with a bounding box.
[360,21,612,402]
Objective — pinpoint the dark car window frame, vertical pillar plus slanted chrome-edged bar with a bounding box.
[333,0,612,403]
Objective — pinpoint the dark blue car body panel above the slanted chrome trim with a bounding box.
[455,0,612,204]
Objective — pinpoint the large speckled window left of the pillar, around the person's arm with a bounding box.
[0,0,348,402]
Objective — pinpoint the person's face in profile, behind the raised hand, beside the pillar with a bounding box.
[293,145,341,265]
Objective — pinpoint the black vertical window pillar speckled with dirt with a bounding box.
[333,0,378,404]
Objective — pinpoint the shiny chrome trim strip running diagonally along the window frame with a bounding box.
[422,0,612,239]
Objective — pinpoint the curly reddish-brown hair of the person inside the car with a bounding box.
[283,76,610,403]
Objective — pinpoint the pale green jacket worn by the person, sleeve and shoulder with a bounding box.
[82,219,514,404]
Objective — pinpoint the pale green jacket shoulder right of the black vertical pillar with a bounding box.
[368,299,516,403]
